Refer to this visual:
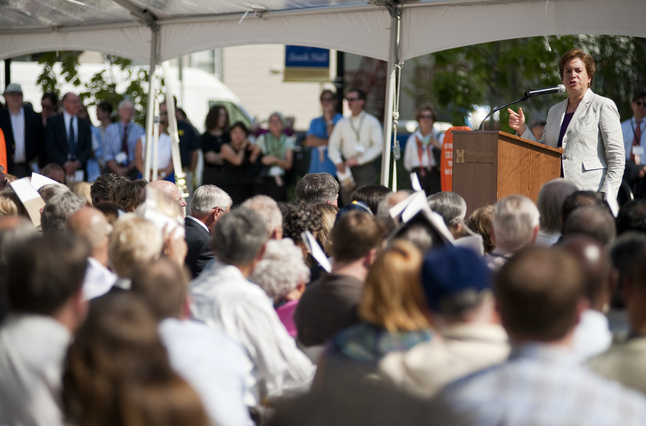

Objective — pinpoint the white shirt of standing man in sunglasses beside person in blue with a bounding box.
[328,111,383,165]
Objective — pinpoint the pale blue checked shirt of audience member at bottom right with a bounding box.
[439,343,646,426]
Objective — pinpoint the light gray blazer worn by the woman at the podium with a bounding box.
[521,89,625,199]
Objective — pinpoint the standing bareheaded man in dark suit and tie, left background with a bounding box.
[46,93,92,180]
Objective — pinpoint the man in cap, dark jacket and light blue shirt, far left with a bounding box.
[0,83,45,178]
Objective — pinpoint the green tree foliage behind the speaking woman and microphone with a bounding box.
[404,36,646,131]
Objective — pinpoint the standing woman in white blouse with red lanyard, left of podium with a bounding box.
[404,105,442,195]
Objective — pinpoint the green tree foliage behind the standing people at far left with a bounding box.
[36,52,148,125]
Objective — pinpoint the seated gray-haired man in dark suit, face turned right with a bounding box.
[184,185,232,278]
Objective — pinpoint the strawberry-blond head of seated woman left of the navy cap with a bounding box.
[359,241,430,332]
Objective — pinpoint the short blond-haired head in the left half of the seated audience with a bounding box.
[108,214,164,278]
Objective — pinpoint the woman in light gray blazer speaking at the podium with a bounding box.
[509,48,625,200]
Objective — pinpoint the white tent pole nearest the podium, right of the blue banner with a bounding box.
[381,4,401,188]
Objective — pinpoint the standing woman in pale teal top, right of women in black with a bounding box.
[251,112,294,201]
